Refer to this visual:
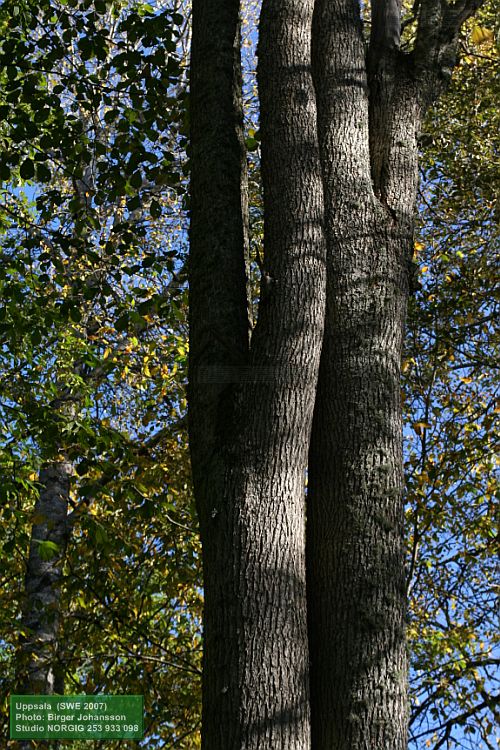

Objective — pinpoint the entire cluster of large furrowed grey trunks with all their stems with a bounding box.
[188,0,480,750]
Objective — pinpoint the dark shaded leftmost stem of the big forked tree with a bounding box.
[188,0,248,468]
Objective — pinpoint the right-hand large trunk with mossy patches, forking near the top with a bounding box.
[307,0,419,750]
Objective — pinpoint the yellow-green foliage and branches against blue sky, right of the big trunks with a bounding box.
[403,5,498,748]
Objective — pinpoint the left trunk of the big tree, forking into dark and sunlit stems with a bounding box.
[189,0,325,750]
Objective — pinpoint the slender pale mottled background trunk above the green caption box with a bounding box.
[17,461,72,704]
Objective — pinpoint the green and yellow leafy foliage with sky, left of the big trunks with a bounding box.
[2,3,200,747]
